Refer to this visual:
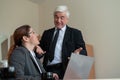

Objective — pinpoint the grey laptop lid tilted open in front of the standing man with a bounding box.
[63,53,94,80]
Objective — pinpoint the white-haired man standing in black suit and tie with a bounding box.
[40,6,87,79]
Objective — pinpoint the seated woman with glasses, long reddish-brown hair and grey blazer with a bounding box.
[8,25,59,80]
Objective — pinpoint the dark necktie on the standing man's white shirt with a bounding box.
[49,29,60,61]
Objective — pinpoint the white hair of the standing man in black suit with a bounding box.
[54,5,70,18]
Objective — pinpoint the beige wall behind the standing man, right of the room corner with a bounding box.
[40,0,120,78]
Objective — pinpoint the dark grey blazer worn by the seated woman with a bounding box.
[9,46,44,80]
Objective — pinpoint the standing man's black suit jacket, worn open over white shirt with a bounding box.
[40,26,87,76]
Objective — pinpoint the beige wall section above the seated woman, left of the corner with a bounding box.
[0,0,42,35]
